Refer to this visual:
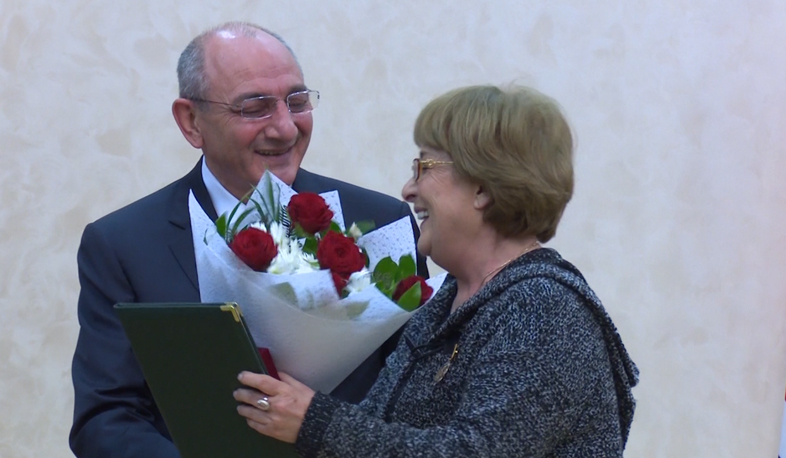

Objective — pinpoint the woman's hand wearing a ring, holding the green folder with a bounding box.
[233,372,314,444]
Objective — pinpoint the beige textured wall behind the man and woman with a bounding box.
[0,0,786,458]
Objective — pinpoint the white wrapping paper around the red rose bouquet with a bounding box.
[189,182,444,392]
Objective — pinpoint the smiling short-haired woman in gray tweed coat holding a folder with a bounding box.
[235,86,638,457]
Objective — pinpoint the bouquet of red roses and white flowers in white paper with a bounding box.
[189,172,444,392]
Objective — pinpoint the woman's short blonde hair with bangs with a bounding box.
[414,86,573,242]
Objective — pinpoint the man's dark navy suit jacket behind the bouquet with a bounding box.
[69,162,426,458]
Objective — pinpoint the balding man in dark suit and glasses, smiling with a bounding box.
[70,23,425,458]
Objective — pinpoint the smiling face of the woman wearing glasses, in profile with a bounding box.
[401,147,482,270]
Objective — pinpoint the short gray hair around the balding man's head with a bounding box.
[177,21,303,100]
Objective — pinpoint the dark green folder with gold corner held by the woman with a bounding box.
[115,303,299,458]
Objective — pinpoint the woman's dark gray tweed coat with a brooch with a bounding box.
[296,248,638,458]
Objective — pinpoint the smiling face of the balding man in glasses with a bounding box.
[194,32,313,198]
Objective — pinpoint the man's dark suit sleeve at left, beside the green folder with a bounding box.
[69,224,180,458]
